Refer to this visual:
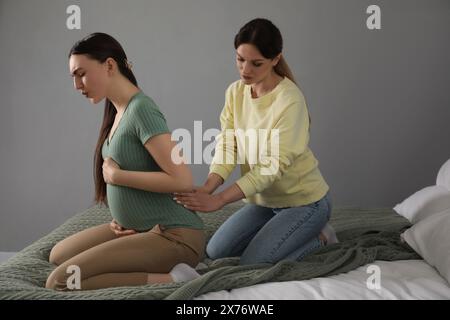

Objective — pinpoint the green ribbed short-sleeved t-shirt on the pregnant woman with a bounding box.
[102,92,204,231]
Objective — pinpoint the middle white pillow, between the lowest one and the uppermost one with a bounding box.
[394,186,450,224]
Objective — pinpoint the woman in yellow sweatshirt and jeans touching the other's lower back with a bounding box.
[175,19,337,264]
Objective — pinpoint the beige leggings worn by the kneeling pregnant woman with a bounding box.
[45,223,205,290]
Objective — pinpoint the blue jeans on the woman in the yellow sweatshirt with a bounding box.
[206,193,331,264]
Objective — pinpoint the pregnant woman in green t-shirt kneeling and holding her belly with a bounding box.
[46,33,205,290]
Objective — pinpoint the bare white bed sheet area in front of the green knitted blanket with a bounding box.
[196,260,450,300]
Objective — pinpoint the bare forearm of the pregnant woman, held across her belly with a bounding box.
[112,169,193,193]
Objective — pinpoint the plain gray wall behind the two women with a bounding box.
[0,0,450,251]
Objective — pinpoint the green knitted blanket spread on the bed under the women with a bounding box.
[0,202,420,299]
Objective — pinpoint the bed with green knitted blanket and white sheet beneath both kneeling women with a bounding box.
[0,202,450,300]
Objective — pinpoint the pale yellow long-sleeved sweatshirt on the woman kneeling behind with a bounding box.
[210,78,329,208]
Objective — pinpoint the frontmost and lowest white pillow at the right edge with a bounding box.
[401,209,450,284]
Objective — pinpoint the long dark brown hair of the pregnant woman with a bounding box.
[69,32,137,206]
